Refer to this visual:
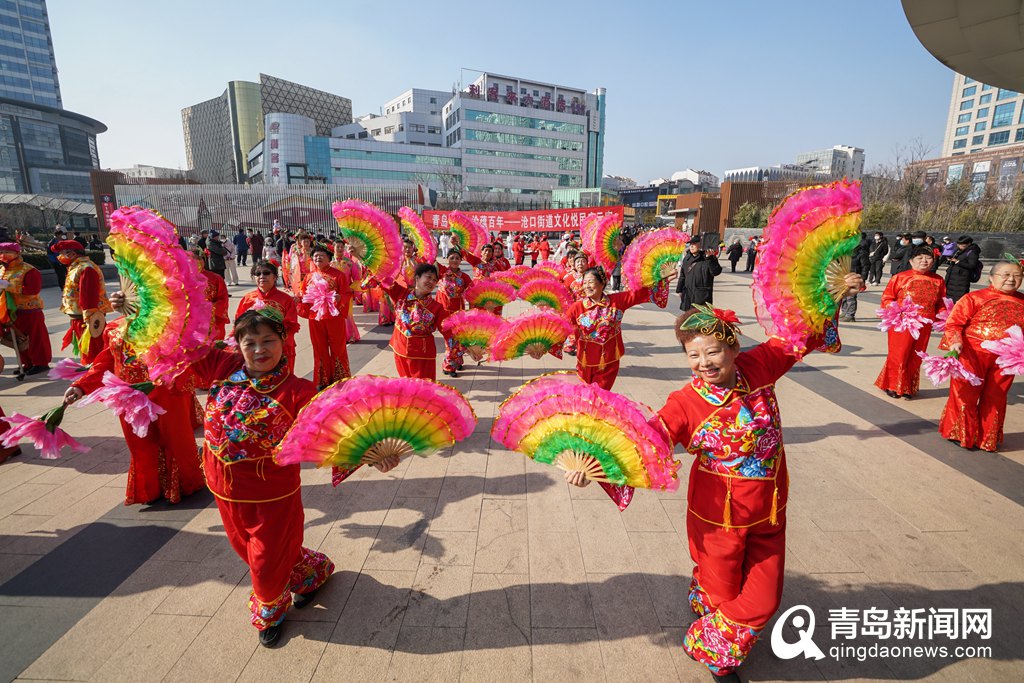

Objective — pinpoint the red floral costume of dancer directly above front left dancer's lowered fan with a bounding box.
[387,284,447,380]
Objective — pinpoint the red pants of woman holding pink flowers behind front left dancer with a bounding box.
[121,387,206,505]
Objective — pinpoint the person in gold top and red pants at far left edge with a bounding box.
[0,242,53,375]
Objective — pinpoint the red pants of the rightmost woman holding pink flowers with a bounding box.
[939,338,1014,453]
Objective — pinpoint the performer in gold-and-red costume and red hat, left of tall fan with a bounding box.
[50,240,114,366]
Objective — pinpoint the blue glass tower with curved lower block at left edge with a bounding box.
[0,0,106,200]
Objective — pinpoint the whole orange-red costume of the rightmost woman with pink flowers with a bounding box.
[939,287,1024,453]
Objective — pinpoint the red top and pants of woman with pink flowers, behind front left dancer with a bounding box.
[72,318,206,505]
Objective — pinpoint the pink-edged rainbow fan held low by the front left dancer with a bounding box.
[274,375,476,469]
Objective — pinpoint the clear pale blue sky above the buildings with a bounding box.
[47,0,952,182]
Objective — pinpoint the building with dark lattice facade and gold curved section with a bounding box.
[181,74,352,183]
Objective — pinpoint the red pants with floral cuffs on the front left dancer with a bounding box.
[216,492,334,631]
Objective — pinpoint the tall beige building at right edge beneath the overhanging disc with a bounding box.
[942,74,1024,157]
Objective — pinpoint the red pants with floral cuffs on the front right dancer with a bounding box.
[683,509,785,674]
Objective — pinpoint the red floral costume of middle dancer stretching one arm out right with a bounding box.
[566,287,651,389]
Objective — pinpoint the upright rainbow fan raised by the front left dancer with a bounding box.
[106,207,213,384]
